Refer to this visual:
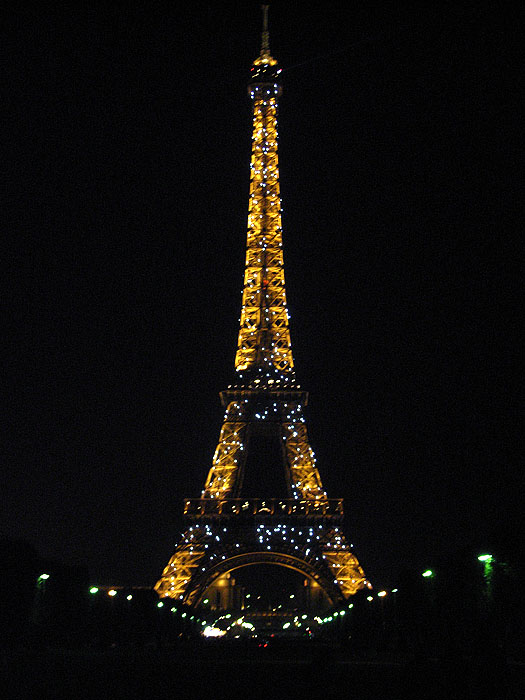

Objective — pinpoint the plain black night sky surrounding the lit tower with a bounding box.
[0,2,523,586]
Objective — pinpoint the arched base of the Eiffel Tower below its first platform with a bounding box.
[155,516,370,608]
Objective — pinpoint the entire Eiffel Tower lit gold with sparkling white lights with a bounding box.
[155,6,371,607]
